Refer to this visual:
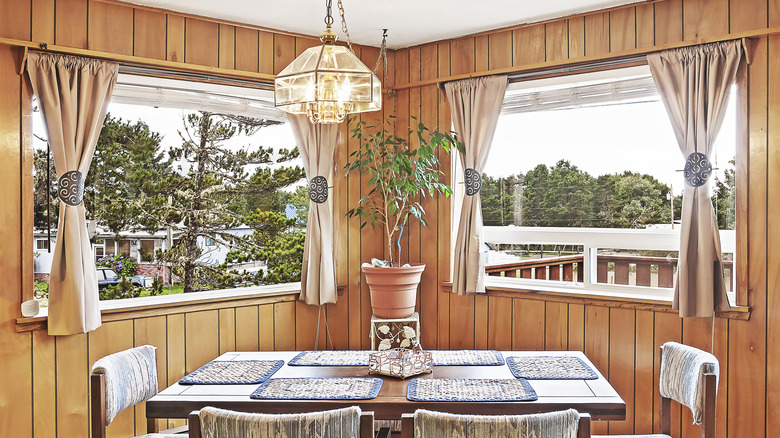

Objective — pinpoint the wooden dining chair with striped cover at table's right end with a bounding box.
[594,342,720,438]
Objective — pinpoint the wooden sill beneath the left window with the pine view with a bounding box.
[16,283,301,333]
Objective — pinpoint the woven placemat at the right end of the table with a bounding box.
[506,356,599,380]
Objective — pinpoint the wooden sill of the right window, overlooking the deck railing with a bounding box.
[442,277,750,321]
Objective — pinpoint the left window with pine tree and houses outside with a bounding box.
[33,72,308,299]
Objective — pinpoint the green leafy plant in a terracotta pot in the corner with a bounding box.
[344,116,463,318]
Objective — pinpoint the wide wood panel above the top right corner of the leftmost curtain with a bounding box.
[88,2,133,55]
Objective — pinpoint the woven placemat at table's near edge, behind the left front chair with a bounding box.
[250,377,382,400]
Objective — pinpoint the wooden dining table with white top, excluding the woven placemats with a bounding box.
[146,351,626,420]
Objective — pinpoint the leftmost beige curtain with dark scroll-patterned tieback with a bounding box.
[27,53,118,335]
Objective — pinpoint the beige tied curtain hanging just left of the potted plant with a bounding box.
[288,114,339,306]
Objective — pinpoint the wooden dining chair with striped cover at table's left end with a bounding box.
[90,345,187,438]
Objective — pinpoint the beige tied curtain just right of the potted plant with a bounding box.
[444,75,507,295]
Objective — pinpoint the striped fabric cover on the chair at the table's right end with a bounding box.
[660,342,720,424]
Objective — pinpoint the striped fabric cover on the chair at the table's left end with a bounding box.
[92,345,157,425]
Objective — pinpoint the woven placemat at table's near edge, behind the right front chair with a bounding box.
[406,379,538,401]
